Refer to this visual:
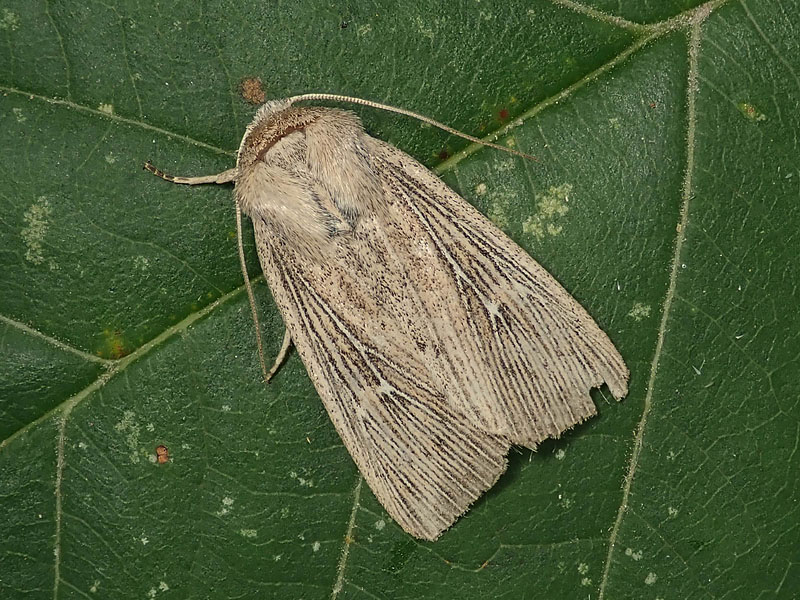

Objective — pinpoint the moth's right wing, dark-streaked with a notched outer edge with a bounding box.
[371,140,628,446]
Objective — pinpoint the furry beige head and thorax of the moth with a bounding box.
[235,100,383,243]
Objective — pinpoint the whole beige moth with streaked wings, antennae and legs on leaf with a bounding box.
[145,94,628,540]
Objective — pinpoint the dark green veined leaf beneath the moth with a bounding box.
[0,0,800,600]
